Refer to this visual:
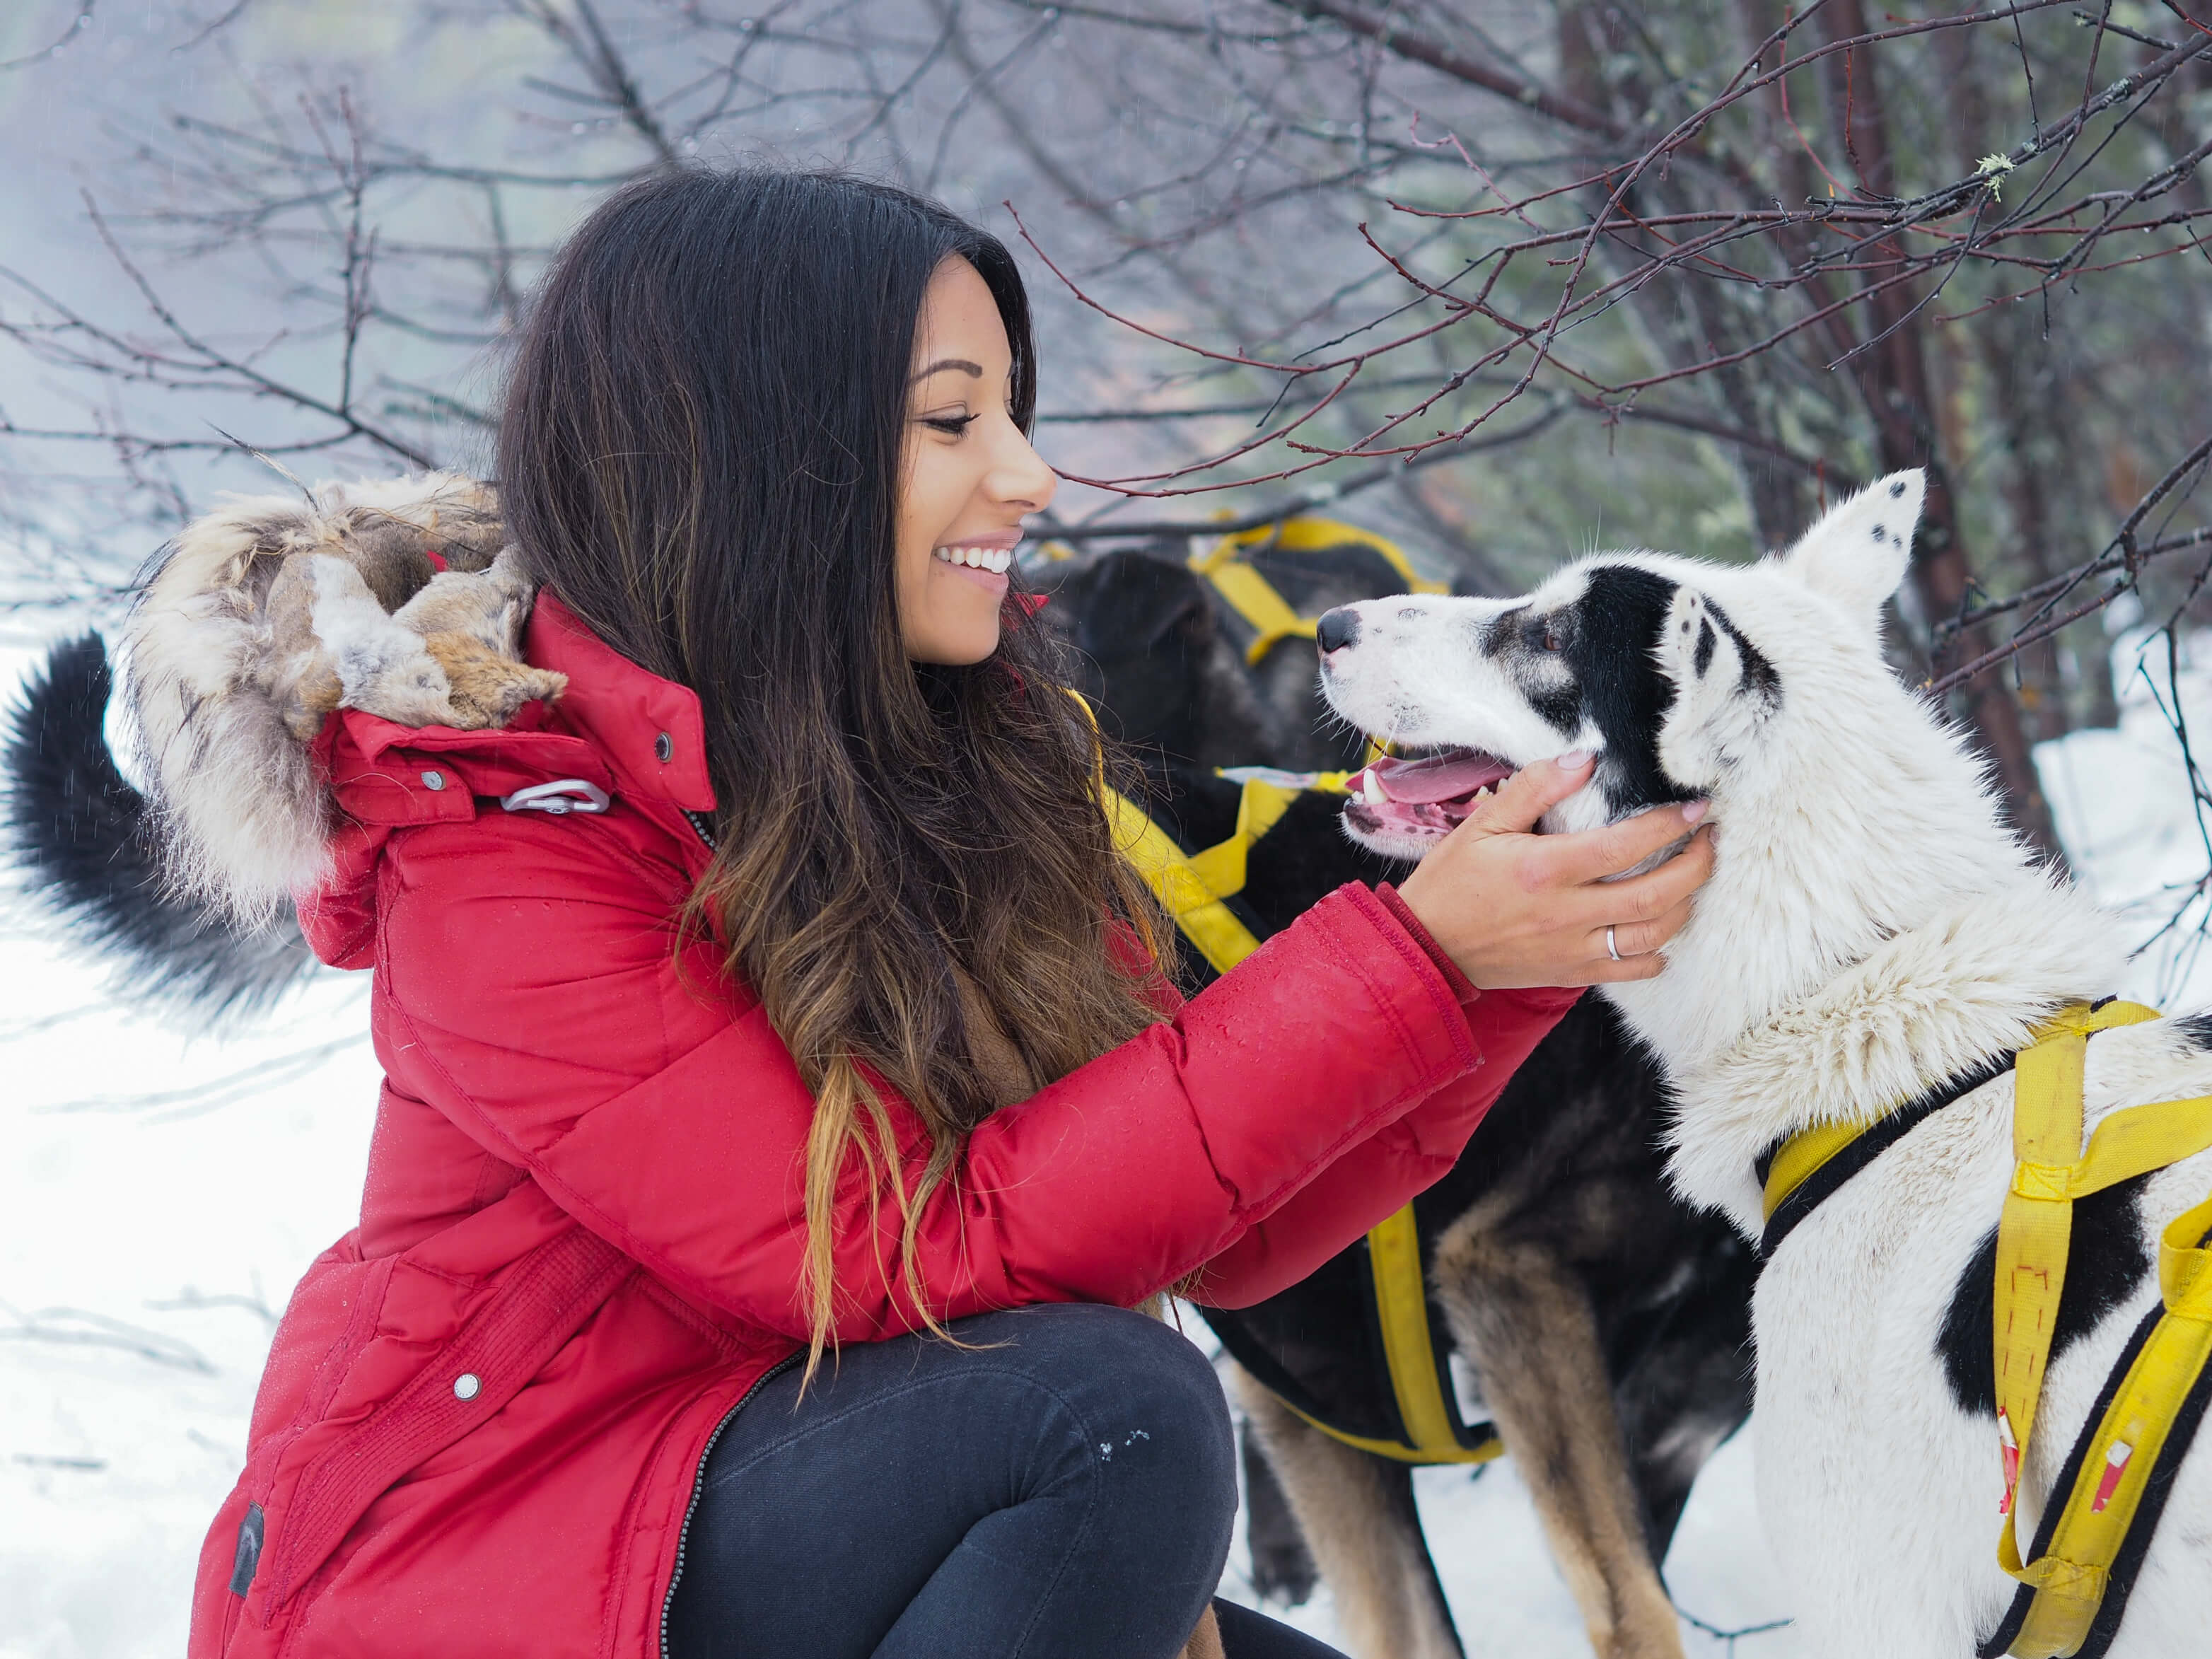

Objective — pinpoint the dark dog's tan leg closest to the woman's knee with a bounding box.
[1234,1369,1462,1659]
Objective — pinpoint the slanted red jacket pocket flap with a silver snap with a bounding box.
[257,1226,637,1617]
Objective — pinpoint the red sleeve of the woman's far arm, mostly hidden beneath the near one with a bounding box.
[1188,986,1582,1308]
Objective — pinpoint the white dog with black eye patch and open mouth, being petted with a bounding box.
[1320,473,2212,1659]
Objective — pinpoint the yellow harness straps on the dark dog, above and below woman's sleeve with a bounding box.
[1100,752,1504,1465]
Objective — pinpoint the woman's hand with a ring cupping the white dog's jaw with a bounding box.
[1398,757,1712,991]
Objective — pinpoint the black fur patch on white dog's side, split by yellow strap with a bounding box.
[1936,1175,2150,1416]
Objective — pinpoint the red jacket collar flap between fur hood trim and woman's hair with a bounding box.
[524,590,714,812]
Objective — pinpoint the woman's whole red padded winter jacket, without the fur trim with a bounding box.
[190,598,1573,1659]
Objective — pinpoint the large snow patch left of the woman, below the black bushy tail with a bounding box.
[0,955,376,1659]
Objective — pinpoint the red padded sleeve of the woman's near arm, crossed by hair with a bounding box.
[374,818,1478,1341]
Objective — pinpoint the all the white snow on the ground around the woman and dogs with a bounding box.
[13,633,2212,1659]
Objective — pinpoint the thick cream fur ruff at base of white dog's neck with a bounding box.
[1668,880,2126,1239]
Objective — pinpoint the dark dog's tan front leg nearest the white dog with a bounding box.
[1436,1212,1681,1659]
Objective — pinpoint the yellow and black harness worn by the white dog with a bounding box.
[1761,1000,2212,1659]
